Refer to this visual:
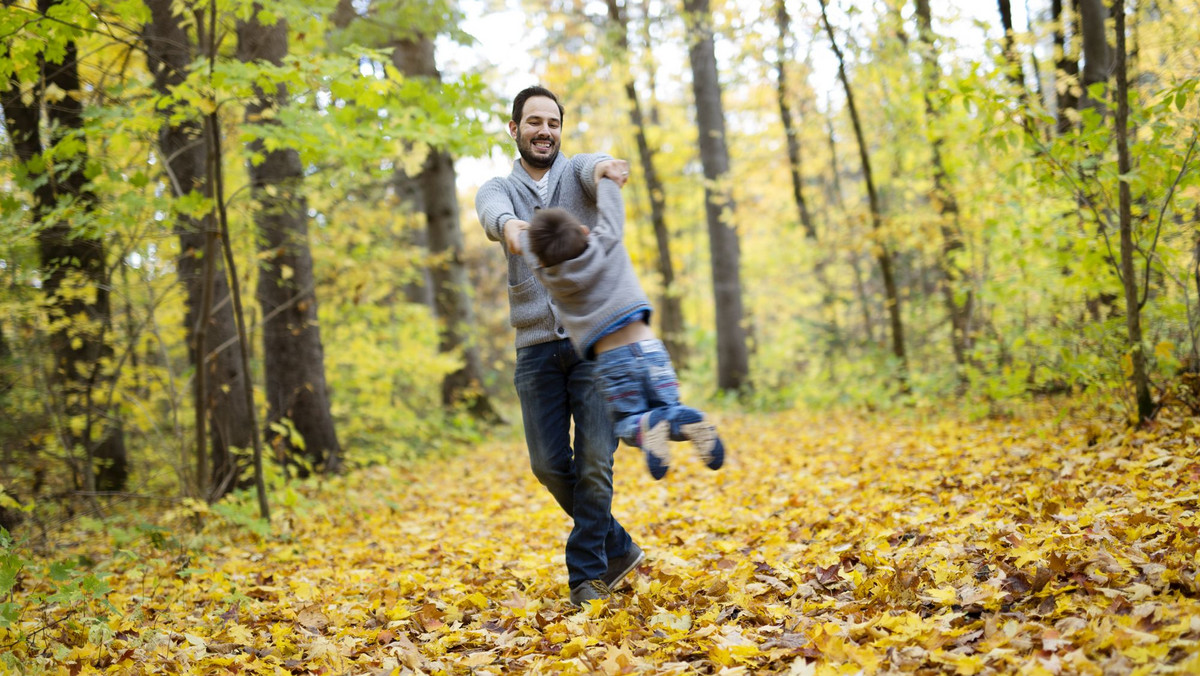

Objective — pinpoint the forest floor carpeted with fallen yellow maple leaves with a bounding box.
[0,405,1200,675]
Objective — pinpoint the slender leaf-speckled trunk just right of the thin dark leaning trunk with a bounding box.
[917,0,974,385]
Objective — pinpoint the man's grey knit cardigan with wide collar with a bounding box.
[475,152,611,349]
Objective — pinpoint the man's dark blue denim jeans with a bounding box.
[514,340,632,587]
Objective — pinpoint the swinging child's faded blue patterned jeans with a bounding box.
[596,340,703,447]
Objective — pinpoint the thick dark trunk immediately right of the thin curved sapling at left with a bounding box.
[238,4,342,472]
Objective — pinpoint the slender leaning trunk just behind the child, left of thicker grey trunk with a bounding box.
[607,0,688,369]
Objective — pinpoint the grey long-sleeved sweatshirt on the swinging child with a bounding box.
[521,179,650,359]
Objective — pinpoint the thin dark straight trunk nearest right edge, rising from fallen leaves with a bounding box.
[1112,0,1154,424]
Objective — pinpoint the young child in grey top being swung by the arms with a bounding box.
[522,179,725,479]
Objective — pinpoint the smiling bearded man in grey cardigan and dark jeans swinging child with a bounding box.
[475,86,644,605]
